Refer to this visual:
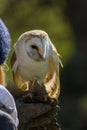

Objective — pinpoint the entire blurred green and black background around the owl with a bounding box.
[0,0,87,130]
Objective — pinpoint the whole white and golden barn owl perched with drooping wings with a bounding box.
[11,30,62,98]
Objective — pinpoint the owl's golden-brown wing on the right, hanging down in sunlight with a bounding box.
[45,46,62,98]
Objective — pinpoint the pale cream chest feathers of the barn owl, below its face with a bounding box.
[19,59,49,80]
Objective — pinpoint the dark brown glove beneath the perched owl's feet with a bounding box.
[16,98,59,130]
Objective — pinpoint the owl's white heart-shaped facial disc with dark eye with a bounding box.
[25,37,47,61]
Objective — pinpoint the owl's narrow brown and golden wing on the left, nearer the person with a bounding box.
[11,52,28,91]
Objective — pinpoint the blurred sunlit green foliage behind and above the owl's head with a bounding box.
[0,0,74,82]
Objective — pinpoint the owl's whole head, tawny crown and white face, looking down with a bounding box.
[18,30,48,61]
